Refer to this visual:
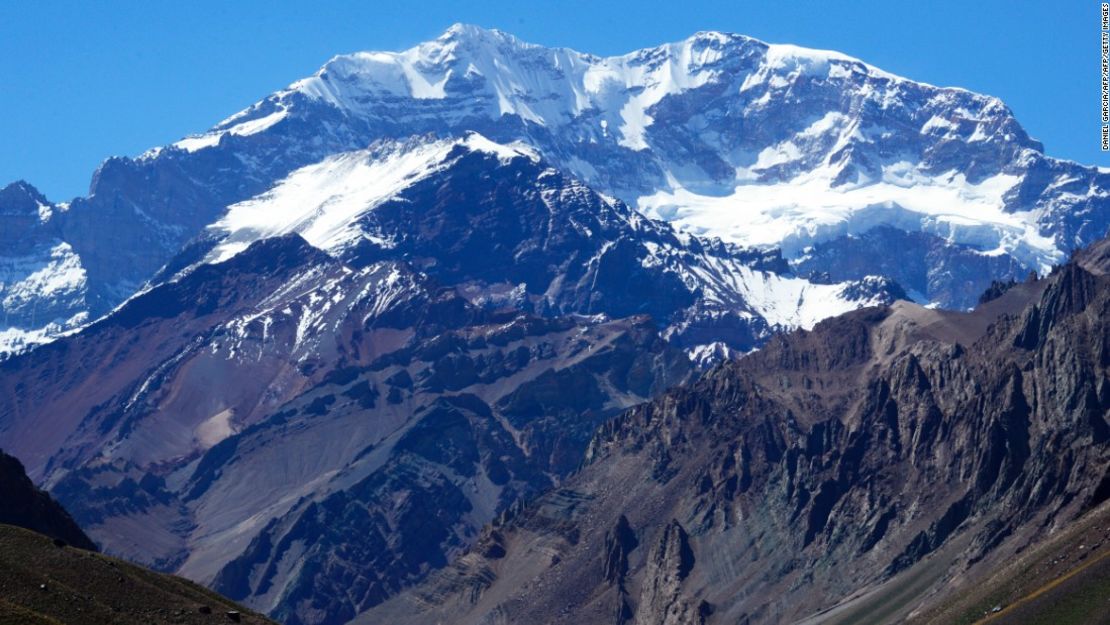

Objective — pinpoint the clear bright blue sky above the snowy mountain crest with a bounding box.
[0,0,1092,201]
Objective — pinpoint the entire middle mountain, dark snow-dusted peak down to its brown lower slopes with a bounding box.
[0,133,899,623]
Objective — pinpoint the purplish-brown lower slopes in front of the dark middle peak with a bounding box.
[0,207,689,623]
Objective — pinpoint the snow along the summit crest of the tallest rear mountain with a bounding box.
[277,24,896,150]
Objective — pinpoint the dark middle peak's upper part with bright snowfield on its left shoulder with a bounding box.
[195,133,897,351]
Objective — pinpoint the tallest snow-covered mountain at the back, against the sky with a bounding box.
[0,26,1110,352]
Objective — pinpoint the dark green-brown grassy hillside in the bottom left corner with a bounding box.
[0,525,272,625]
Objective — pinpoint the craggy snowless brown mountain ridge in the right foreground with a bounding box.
[356,236,1110,625]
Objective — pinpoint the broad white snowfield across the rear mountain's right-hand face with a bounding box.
[638,162,1064,273]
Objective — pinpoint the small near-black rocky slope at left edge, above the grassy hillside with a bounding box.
[0,452,97,551]
